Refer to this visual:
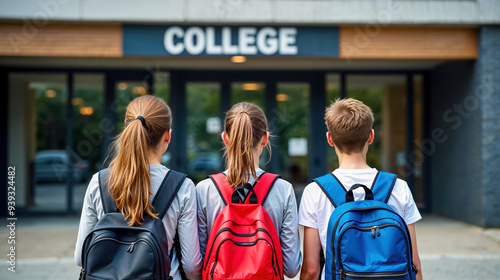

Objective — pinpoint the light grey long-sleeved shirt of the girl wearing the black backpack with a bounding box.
[75,165,202,280]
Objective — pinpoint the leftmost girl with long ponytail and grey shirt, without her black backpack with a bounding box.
[75,95,201,280]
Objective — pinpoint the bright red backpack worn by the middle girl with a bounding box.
[203,173,283,280]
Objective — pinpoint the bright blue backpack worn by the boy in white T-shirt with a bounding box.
[314,172,416,280]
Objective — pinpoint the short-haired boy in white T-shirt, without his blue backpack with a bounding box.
[299,98,422,280]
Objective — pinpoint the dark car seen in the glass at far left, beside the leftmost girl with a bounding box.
[34,150,89,182]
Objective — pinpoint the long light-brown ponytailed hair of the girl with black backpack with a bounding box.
[108,95,171,226]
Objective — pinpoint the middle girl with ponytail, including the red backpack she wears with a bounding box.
[196,102,301,279]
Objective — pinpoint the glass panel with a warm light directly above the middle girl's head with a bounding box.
[231,82,266,111]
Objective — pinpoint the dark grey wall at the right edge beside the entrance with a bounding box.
[426,26,500,227]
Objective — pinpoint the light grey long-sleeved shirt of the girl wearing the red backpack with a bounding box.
[196,168,302,278]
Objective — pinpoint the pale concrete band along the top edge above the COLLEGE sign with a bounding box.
[0,0,500,25]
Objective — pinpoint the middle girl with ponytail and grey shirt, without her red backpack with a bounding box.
[196,102,301,278]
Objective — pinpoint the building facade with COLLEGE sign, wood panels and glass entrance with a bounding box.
[0,0,500,227]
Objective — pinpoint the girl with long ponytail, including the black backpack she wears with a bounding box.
[75,95,201,280]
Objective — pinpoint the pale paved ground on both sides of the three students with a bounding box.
[0,216,500,280]
